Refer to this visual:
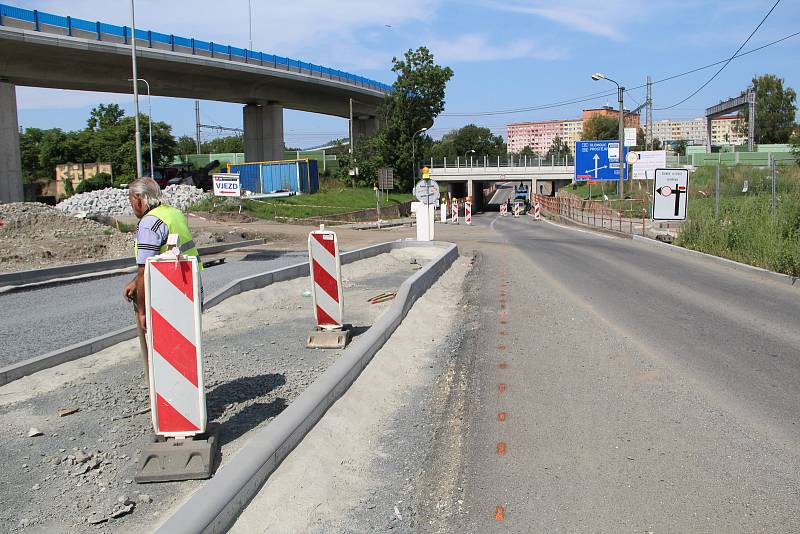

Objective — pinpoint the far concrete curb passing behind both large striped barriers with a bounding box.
[0,241,413,386]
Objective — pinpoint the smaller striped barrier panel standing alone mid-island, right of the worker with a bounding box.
[308,230,344,330]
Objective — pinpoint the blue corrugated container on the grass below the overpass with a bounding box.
[229,159,319,194]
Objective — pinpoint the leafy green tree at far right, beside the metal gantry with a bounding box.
[737,74,797,144]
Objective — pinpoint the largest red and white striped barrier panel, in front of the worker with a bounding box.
[145,255,206,437]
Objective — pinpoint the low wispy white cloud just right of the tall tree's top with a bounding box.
[430,33,567,62]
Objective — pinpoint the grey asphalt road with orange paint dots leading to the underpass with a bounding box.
[420,215,800,532]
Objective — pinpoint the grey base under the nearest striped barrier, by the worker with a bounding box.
[134,427,219,484]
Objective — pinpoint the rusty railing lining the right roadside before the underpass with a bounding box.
[534,195,647,235]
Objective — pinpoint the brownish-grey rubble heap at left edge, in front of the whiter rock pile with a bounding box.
[0,202,134,272]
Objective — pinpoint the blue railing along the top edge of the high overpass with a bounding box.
[0,4,393,93]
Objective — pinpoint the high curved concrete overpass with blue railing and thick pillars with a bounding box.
[0,4,391,202]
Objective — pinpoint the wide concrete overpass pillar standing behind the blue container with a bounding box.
[243,103,284,161]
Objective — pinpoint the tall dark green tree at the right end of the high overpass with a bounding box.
[360,47,453,190]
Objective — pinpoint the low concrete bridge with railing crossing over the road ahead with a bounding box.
[428,156,575,211]
